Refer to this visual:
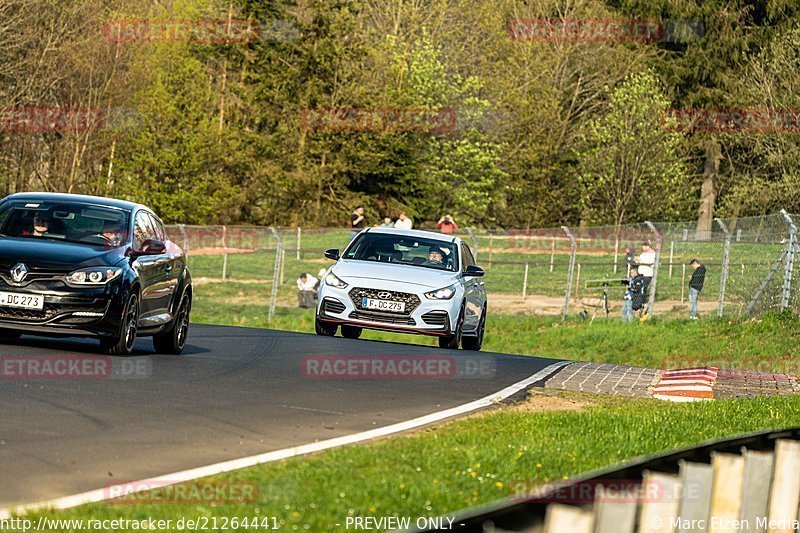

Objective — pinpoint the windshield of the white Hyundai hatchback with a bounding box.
[343,233,458,272]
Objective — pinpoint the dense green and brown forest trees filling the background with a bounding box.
[0,0,800,227]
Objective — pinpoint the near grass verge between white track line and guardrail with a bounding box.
[31,397,800,532]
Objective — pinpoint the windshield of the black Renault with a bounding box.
[0,201,130,248]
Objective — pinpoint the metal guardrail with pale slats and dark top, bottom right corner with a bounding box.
[415,428,800,533]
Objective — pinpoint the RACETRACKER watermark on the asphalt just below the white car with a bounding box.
[300,355,495,379]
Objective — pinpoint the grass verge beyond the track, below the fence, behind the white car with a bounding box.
[192,282,800,374]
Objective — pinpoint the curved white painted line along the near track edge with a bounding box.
[0,361,573,519]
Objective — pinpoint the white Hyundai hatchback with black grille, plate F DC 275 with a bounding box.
[316,228,486,350]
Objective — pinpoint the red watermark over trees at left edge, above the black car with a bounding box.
[0,107,142,133]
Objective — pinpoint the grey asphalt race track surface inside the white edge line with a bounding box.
[0,325,555,507]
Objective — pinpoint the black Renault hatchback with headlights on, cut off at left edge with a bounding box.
[0,193,192,355]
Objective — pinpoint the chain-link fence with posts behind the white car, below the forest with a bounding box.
[164,212,800,318]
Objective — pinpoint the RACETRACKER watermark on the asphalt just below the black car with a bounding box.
[0,355,153,380]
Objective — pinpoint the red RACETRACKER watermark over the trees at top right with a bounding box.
[508,18,703,43]
